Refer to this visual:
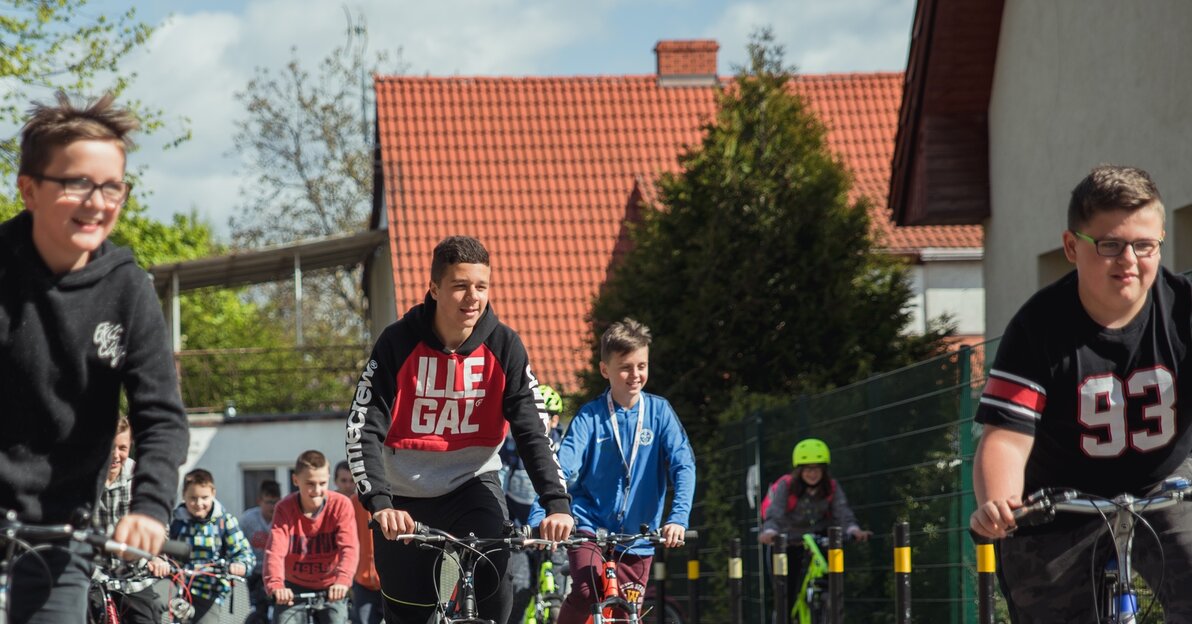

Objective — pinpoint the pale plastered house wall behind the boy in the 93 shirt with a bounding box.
[985,0,1192,336]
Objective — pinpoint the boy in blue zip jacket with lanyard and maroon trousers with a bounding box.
[529,319,695,624]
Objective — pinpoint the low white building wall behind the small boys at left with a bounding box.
[179,418,346,515]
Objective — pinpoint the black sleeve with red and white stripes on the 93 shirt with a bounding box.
[976,313,1048,435]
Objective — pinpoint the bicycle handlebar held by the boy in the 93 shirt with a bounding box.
[1014,477,1192,526]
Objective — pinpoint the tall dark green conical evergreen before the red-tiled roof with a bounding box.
[585,31,950,437]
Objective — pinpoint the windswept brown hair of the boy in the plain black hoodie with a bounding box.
[17,91,141,175]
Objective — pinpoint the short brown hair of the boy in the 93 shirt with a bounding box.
[1068,165,1167,230]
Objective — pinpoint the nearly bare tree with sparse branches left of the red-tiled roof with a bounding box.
[230,16,405,339]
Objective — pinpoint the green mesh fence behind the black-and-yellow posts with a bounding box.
[668,340,997,623]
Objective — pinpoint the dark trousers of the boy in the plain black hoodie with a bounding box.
[8,544,92,624]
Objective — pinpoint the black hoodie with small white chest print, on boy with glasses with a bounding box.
[0,212,188,524]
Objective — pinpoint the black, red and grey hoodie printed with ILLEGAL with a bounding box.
[347,296,571,513]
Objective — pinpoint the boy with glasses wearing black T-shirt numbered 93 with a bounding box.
[970,166,1192,622]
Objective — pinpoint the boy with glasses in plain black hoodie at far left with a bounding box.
[0,93,187,624]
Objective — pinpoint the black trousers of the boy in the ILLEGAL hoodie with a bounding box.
[373,472,513,624]
